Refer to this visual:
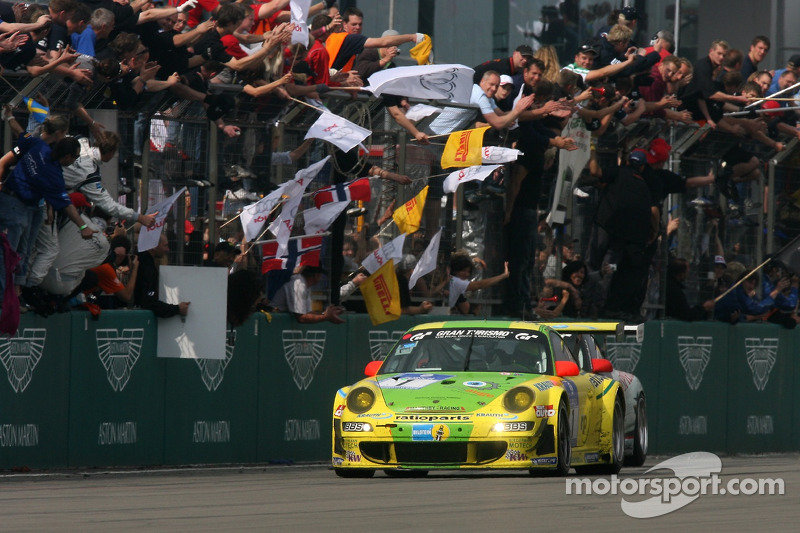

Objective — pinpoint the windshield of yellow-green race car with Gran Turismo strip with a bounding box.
[380,328,553,374]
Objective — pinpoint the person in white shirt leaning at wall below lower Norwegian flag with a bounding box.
[270,265,344,324]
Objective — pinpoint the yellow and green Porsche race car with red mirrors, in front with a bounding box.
[332,321,625,477]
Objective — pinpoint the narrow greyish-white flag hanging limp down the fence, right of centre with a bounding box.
[547,115,592,224]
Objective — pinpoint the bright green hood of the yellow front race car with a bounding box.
[376,371,548,413]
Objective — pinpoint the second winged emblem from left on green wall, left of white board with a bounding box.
[95,328,144,392]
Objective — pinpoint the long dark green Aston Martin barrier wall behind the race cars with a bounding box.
[0,311,800,470]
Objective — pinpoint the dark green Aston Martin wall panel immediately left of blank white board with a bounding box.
[68,311,164,466]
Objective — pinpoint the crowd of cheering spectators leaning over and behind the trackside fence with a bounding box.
[0,0,800,327]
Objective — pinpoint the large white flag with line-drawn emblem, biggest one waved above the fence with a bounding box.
[364,65,475,104]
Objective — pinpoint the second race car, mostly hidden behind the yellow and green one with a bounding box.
[547,322,648,466]
